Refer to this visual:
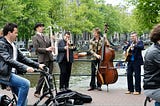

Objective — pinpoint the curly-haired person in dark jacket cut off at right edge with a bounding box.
[143,24,160,106]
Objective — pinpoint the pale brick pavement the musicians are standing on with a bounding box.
[0,77,154,106]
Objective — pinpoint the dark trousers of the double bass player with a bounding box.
[90,60,101,88]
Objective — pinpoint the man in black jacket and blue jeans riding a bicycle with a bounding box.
[0,23,44,106]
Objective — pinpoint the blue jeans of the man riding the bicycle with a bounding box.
[0,73,30,106]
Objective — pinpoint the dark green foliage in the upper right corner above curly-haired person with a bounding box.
[128,0,160,33]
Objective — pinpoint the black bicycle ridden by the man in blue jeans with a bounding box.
[0,67,59,106]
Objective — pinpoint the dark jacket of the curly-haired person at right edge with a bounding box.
[143,44,160,89]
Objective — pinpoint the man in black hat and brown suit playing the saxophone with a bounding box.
[32,23,54,97]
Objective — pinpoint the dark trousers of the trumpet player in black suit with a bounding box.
[59,60,72,89]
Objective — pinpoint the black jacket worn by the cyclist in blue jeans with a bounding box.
[0,37,39,81]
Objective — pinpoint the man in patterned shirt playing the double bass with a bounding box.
[88,28,110,91]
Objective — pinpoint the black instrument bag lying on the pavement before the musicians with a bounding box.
[55,90,92,106]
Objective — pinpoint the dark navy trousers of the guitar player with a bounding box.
[127,62,141,92]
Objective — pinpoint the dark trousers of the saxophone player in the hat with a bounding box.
[35,61,53,94]
